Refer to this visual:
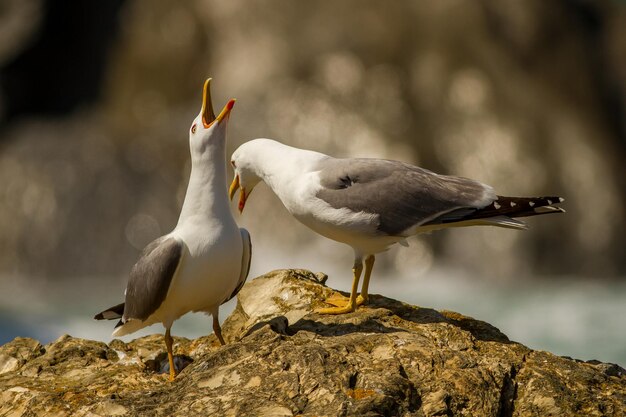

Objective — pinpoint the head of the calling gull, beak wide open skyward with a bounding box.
[189,78,235,155]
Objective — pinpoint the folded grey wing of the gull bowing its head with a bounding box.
[317,158,496,235]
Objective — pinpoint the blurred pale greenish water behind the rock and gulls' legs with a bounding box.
[0,244,626,366]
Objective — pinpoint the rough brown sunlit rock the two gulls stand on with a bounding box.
[0,270,626,417]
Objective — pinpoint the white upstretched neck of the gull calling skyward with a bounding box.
[178,140,230,226]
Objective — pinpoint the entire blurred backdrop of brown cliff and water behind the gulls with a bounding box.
[0,0,626,365]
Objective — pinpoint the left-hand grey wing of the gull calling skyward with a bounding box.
[122,237,184,322]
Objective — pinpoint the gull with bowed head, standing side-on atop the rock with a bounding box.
[229,138,564,314]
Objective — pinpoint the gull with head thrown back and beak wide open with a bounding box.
[94,78,252,381]
